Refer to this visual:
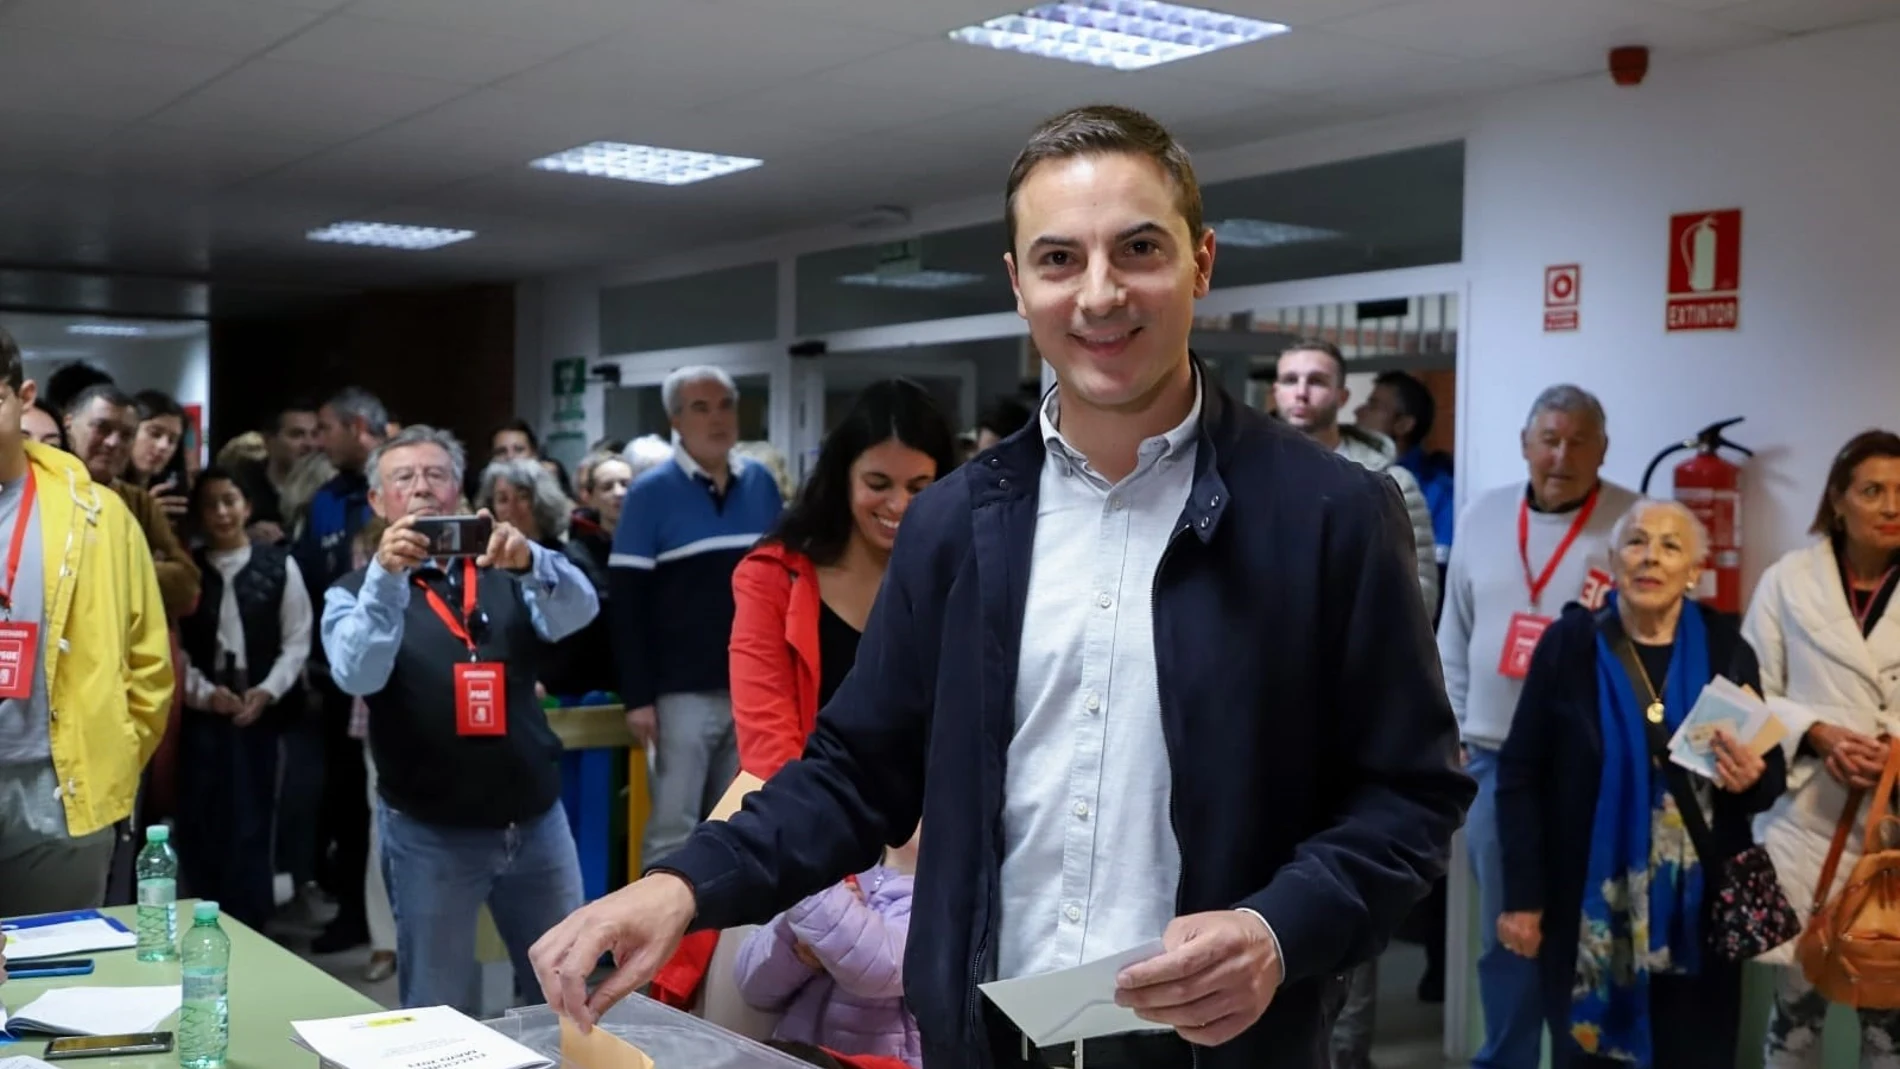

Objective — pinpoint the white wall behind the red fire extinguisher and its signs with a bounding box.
[1459,23,1900,591]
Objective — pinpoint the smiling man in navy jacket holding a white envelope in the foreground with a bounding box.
[532,108,1473,1069]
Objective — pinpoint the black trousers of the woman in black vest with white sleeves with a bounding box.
[175,708,277,930]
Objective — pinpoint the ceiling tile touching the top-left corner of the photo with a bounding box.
[0,0,321,55]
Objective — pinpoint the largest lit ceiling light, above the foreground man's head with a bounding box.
[950,0,1286,70]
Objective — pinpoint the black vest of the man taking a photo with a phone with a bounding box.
[336,566,561,828]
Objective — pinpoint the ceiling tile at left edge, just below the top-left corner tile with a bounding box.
[0,28,234,120]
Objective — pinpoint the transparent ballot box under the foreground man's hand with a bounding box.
[483,995,811,1069]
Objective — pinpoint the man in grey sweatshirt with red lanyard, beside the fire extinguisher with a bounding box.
[1438,385,1636,1069]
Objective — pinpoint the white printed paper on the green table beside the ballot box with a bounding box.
[291,1006,553,1069]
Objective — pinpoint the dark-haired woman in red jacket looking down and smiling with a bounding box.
[730,378,956,778]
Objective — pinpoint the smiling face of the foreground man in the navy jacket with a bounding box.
[1007,152,1214,412]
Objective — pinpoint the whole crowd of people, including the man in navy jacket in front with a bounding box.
[0,100,1900,1069]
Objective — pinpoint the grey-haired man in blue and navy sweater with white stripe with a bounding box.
[608,366,783,862]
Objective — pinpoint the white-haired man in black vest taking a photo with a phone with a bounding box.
[323,425,600,1012]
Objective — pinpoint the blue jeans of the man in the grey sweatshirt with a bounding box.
[1465,746,1543,1069]
